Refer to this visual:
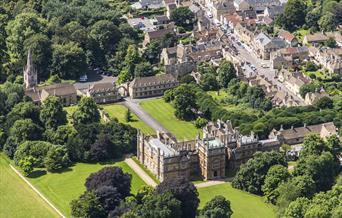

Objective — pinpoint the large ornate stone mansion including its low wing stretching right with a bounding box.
[137,120,337,181]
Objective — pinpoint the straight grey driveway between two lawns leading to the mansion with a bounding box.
[123,97,168,132]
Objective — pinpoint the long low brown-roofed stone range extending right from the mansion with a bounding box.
[269,122,338,145]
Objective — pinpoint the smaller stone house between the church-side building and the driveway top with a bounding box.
[86,83,122,104]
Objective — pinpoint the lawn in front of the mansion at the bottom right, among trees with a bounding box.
[198,183,276,218]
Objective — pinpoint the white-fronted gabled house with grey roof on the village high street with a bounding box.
[254,33,286,60]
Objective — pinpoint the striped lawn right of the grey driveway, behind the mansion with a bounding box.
[140,98,200,140]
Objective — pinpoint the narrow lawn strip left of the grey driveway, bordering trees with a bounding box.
[102,104,155,135]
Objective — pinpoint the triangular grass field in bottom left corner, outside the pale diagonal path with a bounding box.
[0,153,59,218]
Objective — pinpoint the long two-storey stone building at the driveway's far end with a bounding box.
[129,74,179,98]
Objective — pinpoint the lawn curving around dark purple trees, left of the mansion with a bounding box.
[29,161,145,217]
